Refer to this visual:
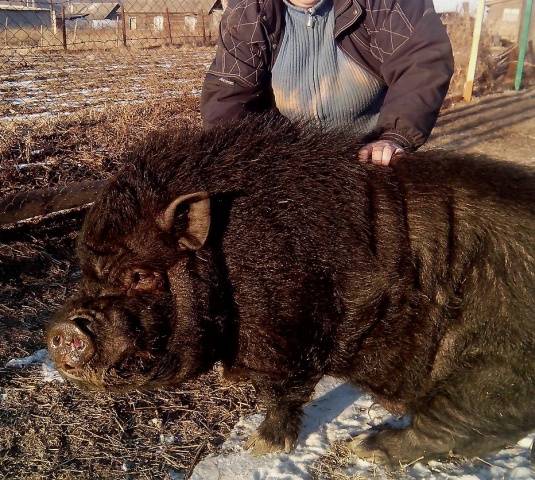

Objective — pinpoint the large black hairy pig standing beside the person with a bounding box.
[47,119,535,463]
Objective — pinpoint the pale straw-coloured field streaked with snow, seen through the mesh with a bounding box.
[0,48,214,121]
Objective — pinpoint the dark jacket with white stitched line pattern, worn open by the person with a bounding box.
[201,0,453,149]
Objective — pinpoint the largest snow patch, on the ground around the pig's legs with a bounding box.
[191,377,535,480]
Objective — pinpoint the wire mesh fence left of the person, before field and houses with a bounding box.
[0,0,223,120]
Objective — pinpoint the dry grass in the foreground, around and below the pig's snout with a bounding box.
[0,202,254,479]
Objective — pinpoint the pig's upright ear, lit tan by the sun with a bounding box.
[156,192,210,250]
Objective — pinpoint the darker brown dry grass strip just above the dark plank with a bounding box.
[0,96,200,197]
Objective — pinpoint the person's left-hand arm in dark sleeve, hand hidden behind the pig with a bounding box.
[201,0,273,128]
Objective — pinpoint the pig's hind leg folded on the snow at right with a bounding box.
[349,365,535,466]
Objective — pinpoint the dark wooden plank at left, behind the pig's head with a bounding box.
[0,180,107,225]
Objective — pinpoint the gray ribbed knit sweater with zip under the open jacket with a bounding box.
[272,0,386,133]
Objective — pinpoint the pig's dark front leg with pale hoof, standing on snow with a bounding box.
[246,378,319,455]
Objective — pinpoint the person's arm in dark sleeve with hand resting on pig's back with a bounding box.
[359,0,453,165]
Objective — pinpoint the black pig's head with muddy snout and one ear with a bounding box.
[46,173,218,391]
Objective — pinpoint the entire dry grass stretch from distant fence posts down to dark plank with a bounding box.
[0,48,213,202]
